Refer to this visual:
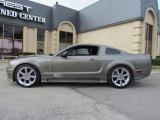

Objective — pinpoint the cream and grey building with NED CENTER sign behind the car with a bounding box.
[0,0,160,58]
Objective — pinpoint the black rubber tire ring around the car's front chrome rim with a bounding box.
[14,64,41,88]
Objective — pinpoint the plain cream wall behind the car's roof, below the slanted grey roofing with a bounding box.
[78,21,142,54]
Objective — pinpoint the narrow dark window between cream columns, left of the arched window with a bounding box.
[37,30,45,54]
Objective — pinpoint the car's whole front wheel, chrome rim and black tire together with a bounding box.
[14,64,40,87]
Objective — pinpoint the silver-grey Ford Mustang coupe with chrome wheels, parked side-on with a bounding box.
[6,44,151,88]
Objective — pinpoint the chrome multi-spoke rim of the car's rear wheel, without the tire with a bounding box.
[111,67,131,87]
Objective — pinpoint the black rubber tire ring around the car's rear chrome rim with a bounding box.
[108,65,133,89]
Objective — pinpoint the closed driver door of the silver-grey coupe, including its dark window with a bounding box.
[53,46,103,80]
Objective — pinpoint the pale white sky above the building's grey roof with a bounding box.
[30,0,160,10]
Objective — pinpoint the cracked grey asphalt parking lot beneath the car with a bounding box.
[0,63,160,120]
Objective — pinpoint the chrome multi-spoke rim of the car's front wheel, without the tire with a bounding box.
[17,66,37,87]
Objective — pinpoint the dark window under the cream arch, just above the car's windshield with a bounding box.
[59,31,73,50]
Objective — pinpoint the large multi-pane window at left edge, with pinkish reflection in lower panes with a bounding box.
[0,24,23,56]
